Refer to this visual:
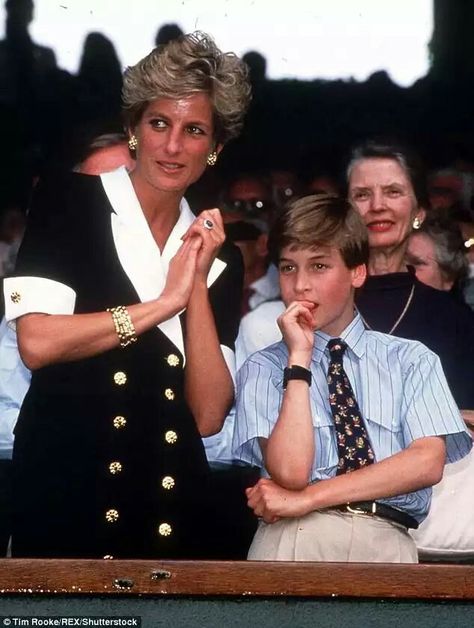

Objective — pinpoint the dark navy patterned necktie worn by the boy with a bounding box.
[327,338,375,475]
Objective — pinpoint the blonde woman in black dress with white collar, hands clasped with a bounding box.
[5,33,250,558]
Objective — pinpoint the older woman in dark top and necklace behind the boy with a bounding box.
[347,141,474,409]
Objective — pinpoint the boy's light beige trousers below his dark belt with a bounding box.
[247,510,418,563]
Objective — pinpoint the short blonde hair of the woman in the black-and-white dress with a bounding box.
[122,31,250,144]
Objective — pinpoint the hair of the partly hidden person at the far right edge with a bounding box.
[413,218,468,286]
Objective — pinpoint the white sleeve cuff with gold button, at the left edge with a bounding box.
[3,277,76,323]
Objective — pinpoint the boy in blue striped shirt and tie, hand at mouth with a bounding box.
[233,195,471,562]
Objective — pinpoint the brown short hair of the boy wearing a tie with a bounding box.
[268,194,369,268]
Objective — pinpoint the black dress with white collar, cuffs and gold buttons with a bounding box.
[5,169,242,558]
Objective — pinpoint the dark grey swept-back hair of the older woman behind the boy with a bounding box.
[346,139,430,210]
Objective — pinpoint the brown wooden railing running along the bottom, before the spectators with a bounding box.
[0,559,474,600]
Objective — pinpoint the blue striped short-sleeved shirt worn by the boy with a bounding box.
[233,314,472,522]
